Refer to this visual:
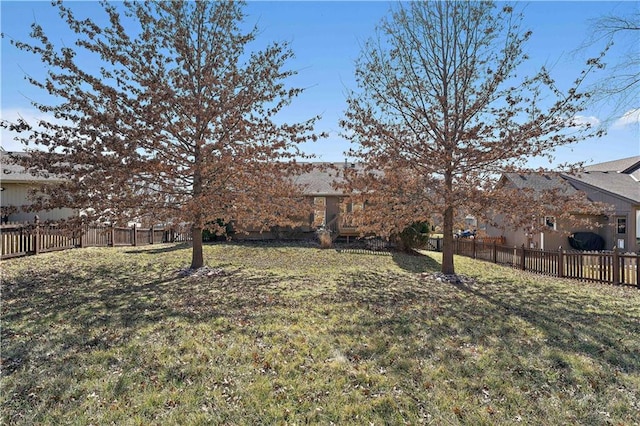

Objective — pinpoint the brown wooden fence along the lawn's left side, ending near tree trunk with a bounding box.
[0,223,191,259]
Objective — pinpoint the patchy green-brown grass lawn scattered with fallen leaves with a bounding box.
[0,244,640,425]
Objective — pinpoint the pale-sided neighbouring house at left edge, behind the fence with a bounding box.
[0,150,74,224]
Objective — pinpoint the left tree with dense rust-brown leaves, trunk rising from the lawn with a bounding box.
[3,1,318,268]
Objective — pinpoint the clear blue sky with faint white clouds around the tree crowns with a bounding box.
[0,1,640,166]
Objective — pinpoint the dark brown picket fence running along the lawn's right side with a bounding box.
[428,238,640,288]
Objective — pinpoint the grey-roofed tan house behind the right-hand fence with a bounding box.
[487,156,640,252]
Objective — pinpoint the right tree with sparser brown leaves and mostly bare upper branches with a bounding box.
[341,1,601,274]
